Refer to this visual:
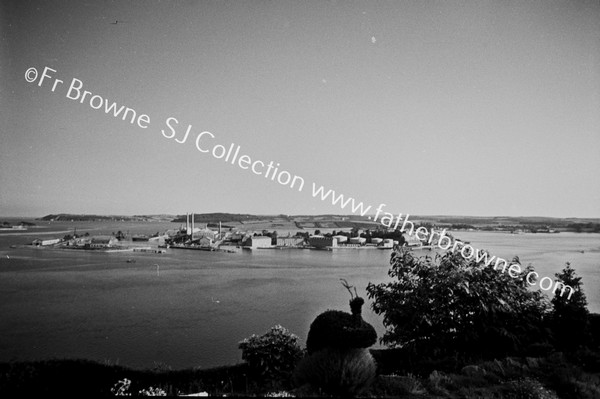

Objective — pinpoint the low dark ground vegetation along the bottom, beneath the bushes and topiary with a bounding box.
[0,351,600,399]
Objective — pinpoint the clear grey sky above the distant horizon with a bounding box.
[0,0,600,218]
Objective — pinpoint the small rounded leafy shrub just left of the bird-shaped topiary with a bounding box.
[239,325,303,380]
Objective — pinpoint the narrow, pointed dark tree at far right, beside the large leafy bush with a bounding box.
[552,262,590,349]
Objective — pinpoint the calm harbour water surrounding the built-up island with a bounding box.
[0,223,600,369]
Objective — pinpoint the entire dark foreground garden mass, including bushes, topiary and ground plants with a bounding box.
[0,249,600,399]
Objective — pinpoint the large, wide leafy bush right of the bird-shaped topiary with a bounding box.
[367,248,549,357]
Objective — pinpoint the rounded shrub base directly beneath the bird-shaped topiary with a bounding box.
[293,348,377,396]
